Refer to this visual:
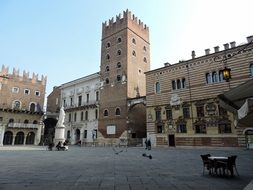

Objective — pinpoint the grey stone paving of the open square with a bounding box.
[0,146,253,190]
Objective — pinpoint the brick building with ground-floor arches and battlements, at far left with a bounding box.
[0,66,46,145]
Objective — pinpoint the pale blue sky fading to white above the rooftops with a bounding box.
[0,0,253,96]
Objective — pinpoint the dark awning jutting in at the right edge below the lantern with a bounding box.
[218,79,253,126]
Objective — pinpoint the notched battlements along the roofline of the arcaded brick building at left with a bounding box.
[0,65,47,85]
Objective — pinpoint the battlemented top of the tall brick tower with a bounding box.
[102,9,149,41]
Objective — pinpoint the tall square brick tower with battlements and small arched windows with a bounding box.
[98,10,150,141]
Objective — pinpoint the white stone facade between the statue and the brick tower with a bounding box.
[60,73,100,145]
